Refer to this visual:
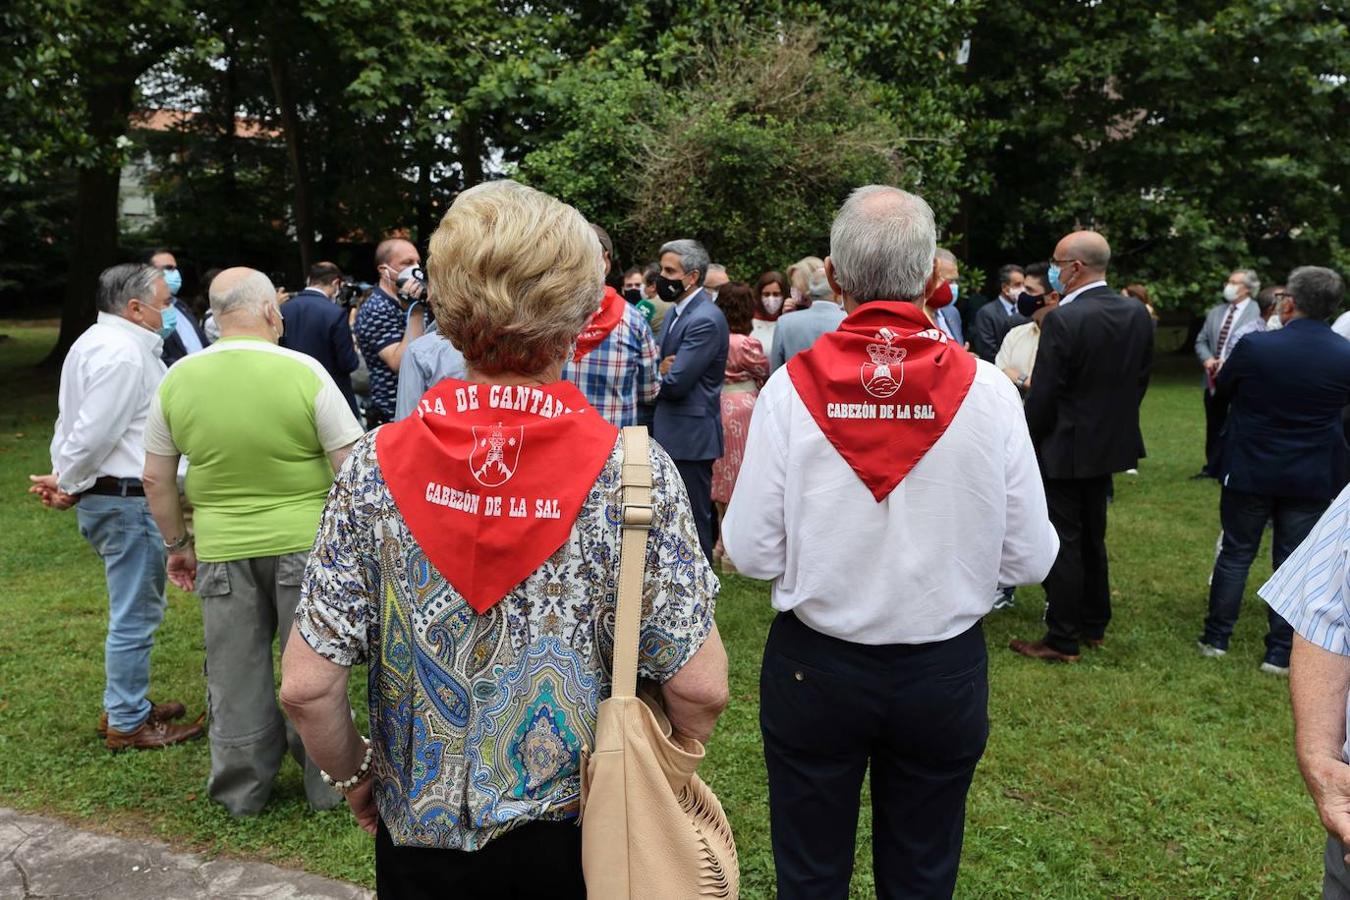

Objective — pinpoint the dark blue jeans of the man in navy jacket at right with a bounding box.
[1200,487,1327,665]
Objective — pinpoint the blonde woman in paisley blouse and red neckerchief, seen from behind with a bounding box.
[282,181,726,899]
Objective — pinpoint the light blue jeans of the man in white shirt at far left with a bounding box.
[76,494,166,731]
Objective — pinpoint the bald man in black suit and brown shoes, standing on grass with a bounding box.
[1010,231,1153,663]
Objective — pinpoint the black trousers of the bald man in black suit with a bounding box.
[1045,475,1111,653]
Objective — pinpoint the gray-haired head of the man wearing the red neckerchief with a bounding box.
[830,185,937,304]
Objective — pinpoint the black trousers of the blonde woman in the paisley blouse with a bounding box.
[375,820,586,900]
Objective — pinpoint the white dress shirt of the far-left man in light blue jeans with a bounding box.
[51,313,166,494]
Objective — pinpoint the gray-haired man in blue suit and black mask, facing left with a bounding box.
[652,240,730,560]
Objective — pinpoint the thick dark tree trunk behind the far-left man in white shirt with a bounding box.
[42,73,136,367]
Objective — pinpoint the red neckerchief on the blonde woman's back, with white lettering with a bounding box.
[375,378,618,613]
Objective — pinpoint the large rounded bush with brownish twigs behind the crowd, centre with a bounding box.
[520,23,982,278]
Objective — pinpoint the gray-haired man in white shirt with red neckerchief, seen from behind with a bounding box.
[722,185,1058,900]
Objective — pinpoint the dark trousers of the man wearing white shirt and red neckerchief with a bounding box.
[760,613,990,900]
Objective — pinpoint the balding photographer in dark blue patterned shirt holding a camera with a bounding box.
[356,237,427,428]
